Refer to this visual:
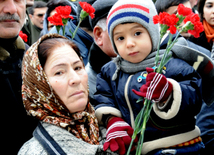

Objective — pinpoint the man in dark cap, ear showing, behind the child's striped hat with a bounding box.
[86,0,117,105]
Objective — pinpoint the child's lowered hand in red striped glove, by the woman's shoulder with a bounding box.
[103,117,137,154]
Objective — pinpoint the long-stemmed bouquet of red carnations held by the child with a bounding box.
[127,4,204,155]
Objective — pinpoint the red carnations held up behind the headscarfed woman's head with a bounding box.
[48,2,95,39]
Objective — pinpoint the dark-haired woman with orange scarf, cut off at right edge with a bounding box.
[190,0,214,60]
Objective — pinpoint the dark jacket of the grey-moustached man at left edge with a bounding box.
[0,37,37,154]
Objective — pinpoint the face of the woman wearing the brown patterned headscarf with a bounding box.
[44,45,88,113]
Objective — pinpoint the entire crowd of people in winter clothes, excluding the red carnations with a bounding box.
[0,0,214,155]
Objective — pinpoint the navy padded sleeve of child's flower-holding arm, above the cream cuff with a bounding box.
[168,59,202,117]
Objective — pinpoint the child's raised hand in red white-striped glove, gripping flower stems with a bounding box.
[132,68,173,102]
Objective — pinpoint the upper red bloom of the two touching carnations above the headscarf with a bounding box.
[56,6,73,19]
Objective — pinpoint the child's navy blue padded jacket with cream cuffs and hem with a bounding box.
[94,58,202,154]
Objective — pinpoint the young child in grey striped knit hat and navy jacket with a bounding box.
[94,0,204,155]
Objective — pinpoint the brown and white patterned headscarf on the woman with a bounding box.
[22,34,99,144]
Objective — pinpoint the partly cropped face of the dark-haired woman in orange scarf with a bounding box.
[203,0,214,27]
